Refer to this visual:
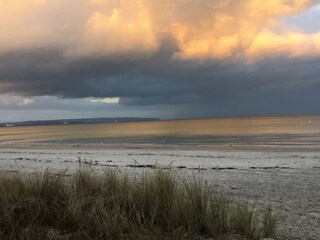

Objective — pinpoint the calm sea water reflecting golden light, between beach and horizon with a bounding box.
[0,116,320,145]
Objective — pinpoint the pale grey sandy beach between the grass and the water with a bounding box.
[0,144,320,240]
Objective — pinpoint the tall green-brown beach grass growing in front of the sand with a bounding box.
[0,170,277,240]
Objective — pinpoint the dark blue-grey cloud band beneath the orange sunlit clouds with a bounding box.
[0,41,320,115]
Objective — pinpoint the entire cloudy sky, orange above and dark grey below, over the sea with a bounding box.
[0,0,320,122]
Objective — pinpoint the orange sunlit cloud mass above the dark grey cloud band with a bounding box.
[0,0,320,60]
